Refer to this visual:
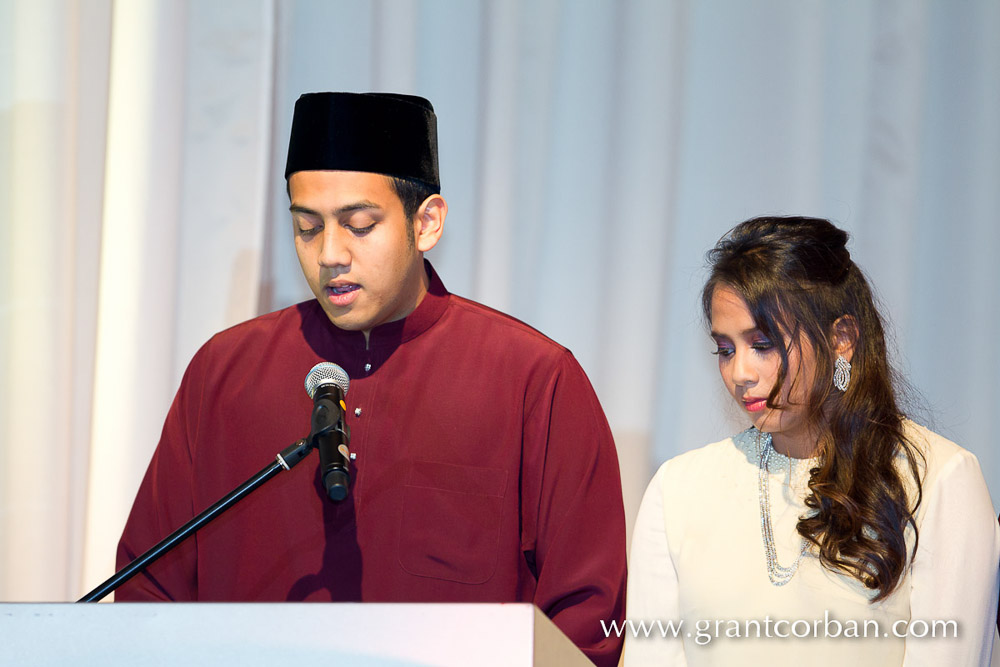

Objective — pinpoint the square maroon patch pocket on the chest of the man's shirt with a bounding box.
[399,461,507,584]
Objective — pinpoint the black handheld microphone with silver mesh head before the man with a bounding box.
[305,361,351,502]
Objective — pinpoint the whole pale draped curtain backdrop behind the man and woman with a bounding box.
[0,0,1000,601]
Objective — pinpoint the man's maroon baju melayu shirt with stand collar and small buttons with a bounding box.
[116,265,625,665]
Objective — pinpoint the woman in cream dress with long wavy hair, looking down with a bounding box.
[625,218,1000,667]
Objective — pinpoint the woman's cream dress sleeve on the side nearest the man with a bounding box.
[625,464,687,667]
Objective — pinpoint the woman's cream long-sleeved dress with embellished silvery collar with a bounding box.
[625,422,1000,667]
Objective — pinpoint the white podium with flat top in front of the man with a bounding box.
[0,602,598,667]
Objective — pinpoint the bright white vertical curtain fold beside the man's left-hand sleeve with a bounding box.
[83,0,186,586]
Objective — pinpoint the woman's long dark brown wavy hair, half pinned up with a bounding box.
[702,217,922,602]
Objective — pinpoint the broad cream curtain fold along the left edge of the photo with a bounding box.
[0,0,110,600]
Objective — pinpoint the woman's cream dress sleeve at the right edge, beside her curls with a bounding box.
[903,450,1000,667]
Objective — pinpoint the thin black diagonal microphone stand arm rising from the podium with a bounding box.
[77,436,316,602]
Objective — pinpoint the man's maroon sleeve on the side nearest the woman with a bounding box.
[522,352,626,667]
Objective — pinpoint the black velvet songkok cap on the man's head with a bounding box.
[285,93,441,190]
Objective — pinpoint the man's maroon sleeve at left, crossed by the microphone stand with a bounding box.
[115,352,204,602]
